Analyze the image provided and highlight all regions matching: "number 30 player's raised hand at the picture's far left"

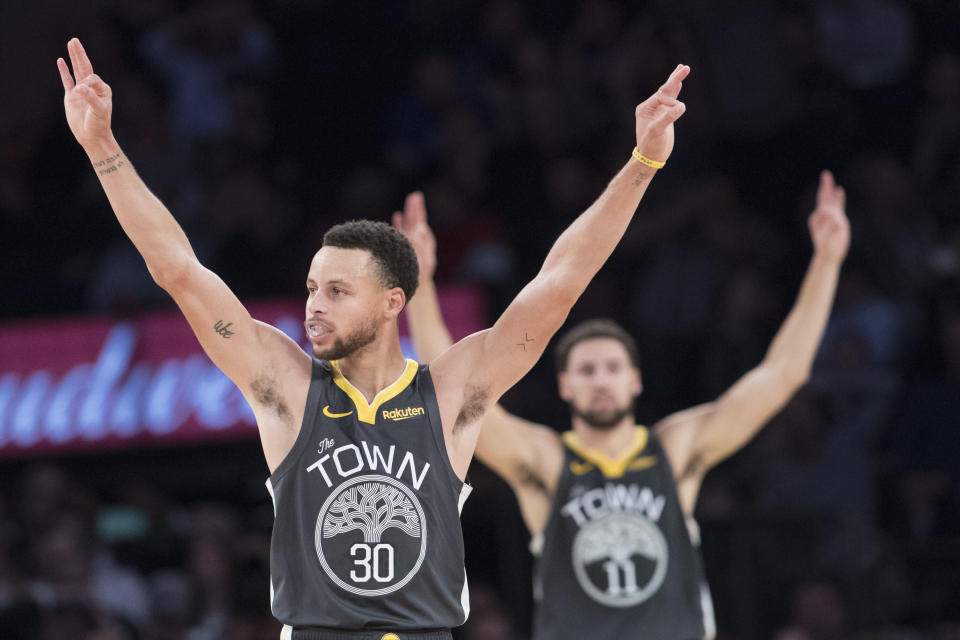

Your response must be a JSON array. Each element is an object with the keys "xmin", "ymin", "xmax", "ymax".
[{"xmin": 57, "ymin": 38, "xmax": 113, "ymax": 148}]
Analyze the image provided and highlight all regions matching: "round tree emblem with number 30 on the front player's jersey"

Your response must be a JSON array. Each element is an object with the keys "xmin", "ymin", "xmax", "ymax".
[{"xmin": 314, "ymin": 475, "xmax": 427, "ymax": 596}]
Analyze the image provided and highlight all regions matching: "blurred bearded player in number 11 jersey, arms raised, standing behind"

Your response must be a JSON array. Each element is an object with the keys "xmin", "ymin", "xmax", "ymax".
[{"xmin": 402, "ymin": 171, "xmax": 850, "ymax": 640}]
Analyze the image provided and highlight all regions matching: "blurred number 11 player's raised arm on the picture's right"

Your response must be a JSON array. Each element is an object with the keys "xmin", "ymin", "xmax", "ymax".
[{"xmin": 657, "ymin": 171, "xmax": 850, "ymax": 512}]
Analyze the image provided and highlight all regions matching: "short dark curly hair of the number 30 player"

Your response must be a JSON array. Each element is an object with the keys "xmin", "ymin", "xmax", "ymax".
[{"xmin": 323, "ymin": 220, "xmax": 420, "ymax": 300}]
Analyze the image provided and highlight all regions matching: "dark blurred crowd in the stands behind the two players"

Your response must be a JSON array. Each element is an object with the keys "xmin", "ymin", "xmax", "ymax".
[{"xmin": 0, "ymin": 0, "xmax": 960, "ymax": 640}]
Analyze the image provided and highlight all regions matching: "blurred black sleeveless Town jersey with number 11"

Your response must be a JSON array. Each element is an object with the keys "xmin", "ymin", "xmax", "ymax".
[{"xmin": 533, "ymin": 427, "xmax": 715, "ymax": 640}]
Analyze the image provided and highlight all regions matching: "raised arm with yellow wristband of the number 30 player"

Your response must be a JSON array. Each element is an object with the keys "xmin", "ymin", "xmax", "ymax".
[{"xmin": 433, "ymin": 65, "xmax": 690, "ymax": 478}]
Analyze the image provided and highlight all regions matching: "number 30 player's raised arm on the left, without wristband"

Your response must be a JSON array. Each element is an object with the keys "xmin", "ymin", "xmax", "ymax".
[{"xmin": 57, "ymin": 38, "xmax": 310, "ymax": 469}]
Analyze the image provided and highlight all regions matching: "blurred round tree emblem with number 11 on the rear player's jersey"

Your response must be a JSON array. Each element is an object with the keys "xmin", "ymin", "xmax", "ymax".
[{"xmin": 573, "ymin": 511, "xmax": 668, "ymax": 607}]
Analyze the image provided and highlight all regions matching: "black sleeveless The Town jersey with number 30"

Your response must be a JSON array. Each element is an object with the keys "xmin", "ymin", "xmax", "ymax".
[{"xmin": 267, "ymin": 360, "xmax": 470, "ymax": 631}]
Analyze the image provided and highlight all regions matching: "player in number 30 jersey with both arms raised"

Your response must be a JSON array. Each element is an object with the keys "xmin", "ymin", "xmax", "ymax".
[{"xmin": 57, "ymin": 39, "xmax": 690, "ymax": 640}]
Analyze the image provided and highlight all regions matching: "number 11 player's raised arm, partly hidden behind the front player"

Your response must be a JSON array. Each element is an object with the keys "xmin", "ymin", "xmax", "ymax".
[{"xmin": 393, "ymin": 192, "xmax": 563, "ymax": 532}]
